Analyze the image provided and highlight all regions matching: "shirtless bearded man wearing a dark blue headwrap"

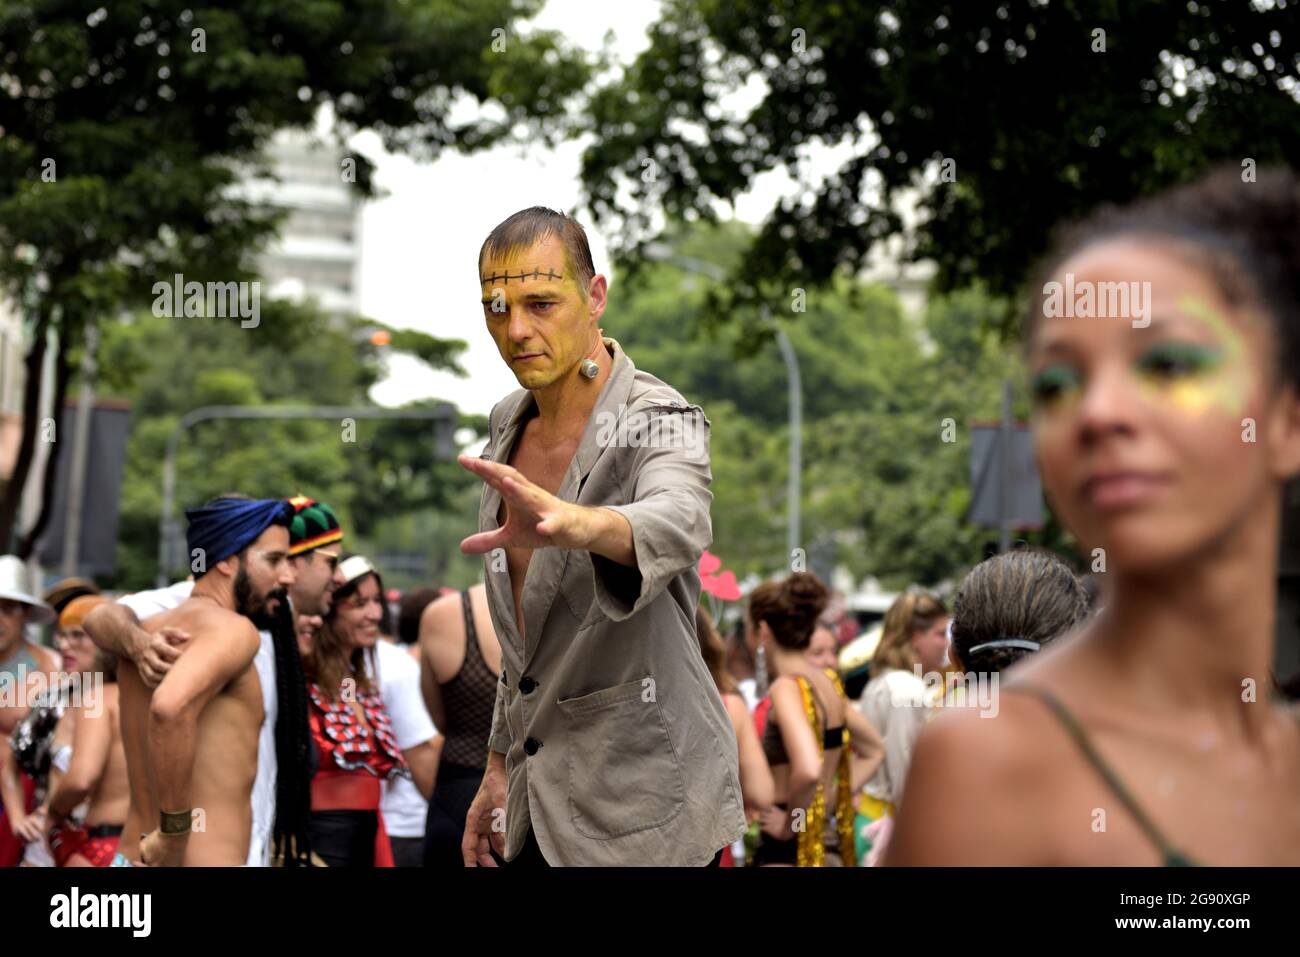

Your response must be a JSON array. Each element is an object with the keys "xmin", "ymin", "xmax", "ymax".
[{"xmin": 118, "ymin": 498, "xmax": 294, "ymax": 866}]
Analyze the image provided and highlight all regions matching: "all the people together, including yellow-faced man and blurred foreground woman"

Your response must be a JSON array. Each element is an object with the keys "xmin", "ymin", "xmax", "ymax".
[{"xmin": 0, "ymin": 170, "xmax": 1300, "ymax": 867}]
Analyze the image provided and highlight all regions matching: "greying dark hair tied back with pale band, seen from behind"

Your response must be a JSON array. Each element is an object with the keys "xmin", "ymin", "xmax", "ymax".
[{"xmin": 953, "ymin": 549, "xmax": 1088, "ymax": 674}]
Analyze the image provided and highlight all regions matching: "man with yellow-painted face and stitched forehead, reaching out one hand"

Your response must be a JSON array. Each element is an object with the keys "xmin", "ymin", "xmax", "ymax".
[{"xmin": 460, "ymin": 207, "xmax": 745, "ymax": 866}]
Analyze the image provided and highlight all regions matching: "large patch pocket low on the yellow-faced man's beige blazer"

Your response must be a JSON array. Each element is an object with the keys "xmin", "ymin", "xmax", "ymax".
[{"xmin": 556, "ymin": 677, "xmax": 685, "ymax": 840}]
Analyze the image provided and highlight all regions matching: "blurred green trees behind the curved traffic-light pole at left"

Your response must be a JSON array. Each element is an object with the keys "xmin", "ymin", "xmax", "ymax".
[{"xmin": 99, "ymin": 302, "xmax": 486, "ymax": 588}]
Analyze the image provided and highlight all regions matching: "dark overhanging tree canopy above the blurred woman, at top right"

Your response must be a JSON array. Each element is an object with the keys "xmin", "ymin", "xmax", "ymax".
[{"xmin": 582, "ymin": 0, "xmax": 1300, "ymax": 325}]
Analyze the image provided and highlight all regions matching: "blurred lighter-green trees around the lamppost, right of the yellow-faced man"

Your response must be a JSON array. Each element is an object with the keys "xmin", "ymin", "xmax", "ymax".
[{"xmin": 613, "ymin": 224, "xmax": 1063, "ymax": 586}]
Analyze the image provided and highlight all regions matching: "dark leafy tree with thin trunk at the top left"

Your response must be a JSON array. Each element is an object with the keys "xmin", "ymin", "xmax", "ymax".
[{"xmin": 0, "ymin": 0, "xmax": 589, "ymax": 551}]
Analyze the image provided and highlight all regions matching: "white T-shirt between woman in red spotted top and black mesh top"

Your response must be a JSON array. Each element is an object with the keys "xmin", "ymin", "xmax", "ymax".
[{"xmin": 374, "ymin": 638, "xmax": 438, "ymax": 837}]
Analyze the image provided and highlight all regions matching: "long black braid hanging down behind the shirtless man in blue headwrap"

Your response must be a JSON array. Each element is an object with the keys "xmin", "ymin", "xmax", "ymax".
[{"xmin": 270, "ymin": 601, "xmax": 312, "ymax": 867}]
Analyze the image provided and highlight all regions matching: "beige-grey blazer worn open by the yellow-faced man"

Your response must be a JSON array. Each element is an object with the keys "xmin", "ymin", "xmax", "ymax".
[{"xmin": 478, "ymin": 339, "xmax": 745, "ymax": 866}]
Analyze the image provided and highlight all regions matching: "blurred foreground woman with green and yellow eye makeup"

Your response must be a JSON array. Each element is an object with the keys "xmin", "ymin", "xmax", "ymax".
[{"xmin": 888, "ymin": 168, "xmax": 1300, "ymax": 866}]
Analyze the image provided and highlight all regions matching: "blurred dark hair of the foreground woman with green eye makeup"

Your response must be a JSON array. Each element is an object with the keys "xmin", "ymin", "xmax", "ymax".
[{"xmin": 1024, "ymin": 165, "xmax": 1300, "ymax": 387}]
